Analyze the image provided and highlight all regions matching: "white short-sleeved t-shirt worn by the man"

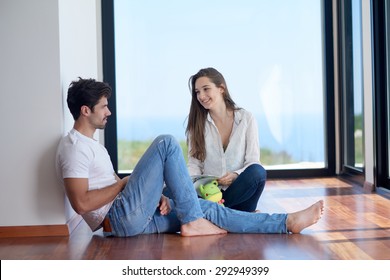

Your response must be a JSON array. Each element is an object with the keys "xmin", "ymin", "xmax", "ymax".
[{"xmin": 56, "ymin": 128, "xmax": 116, "ymax": 231}]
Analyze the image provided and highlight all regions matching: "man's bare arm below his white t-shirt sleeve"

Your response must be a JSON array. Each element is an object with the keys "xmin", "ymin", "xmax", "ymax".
[{"xmin": 64, "ymin": 176, "xmax": 128, "ymax": 215}]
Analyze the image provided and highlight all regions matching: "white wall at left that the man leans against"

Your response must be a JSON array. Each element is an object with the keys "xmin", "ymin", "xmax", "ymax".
[{"xmin": 0, "ymin": 0, "xmax": 101, "ymax": 226}]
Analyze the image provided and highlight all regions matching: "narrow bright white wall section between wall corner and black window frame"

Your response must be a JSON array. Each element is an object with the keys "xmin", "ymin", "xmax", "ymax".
[{"xmin": 58, "ymin": 0, "xmax": 101, "ymax": 220}]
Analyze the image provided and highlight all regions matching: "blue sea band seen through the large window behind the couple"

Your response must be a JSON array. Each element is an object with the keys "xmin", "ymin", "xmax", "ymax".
[{"xmin": 118, "ymin": 112, "xmax": 325, "ymax": 162}]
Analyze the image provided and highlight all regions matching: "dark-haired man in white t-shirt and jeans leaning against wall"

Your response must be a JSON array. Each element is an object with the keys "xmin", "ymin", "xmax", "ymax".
[{"xmin": 56, "ymin": 78, "xmax": 323, "ymax": 236}]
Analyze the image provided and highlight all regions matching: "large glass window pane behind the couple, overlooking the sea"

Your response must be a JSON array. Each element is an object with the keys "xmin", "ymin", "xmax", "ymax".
[{"xmin": 115, "ymin": 0, "xmax": 326, "ymax": 172}]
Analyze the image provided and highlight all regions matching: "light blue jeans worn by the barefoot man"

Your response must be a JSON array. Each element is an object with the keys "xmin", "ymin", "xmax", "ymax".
[{"xmin": 107, "ymin": 135, "xmax": 287, "ymax": 236}]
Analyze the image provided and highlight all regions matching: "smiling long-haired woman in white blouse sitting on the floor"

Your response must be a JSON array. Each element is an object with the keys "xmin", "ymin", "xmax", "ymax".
[{"xmin": 186, "ymin": 68, "xmax": 266, "ymax": 212}]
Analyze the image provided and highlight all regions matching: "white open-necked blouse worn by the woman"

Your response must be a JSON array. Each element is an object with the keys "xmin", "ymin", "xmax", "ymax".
[{"xmin": 187, "ymin": 109, "xmax": 260, "ymax": 180}]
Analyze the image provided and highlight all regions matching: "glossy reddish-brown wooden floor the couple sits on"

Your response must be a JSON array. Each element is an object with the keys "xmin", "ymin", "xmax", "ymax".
[{"xmin": 0, "ymin": 178, "xmax": 390, "ymax": 260}]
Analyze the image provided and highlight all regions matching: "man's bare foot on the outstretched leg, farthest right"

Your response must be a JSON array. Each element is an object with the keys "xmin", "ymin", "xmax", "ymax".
[{"xmin": 286, "ymin": 200, "xmax": 324, "ymax": 233}]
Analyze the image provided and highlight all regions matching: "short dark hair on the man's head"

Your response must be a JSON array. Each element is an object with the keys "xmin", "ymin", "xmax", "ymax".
[{"xmin": 66, "ymin": 77, "xmax": 112, "ymax": 120}]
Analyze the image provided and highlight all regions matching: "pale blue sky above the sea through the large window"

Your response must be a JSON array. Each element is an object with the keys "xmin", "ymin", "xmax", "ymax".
[{"xmin": 115, "ymin": 0, "xmax": 322, "ymax": 117}]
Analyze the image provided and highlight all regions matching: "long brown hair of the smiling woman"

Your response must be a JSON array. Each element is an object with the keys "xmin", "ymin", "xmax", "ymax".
[{"xmin": 186, "ymin": 67, "xmax": 238, "ymax": 161}]
